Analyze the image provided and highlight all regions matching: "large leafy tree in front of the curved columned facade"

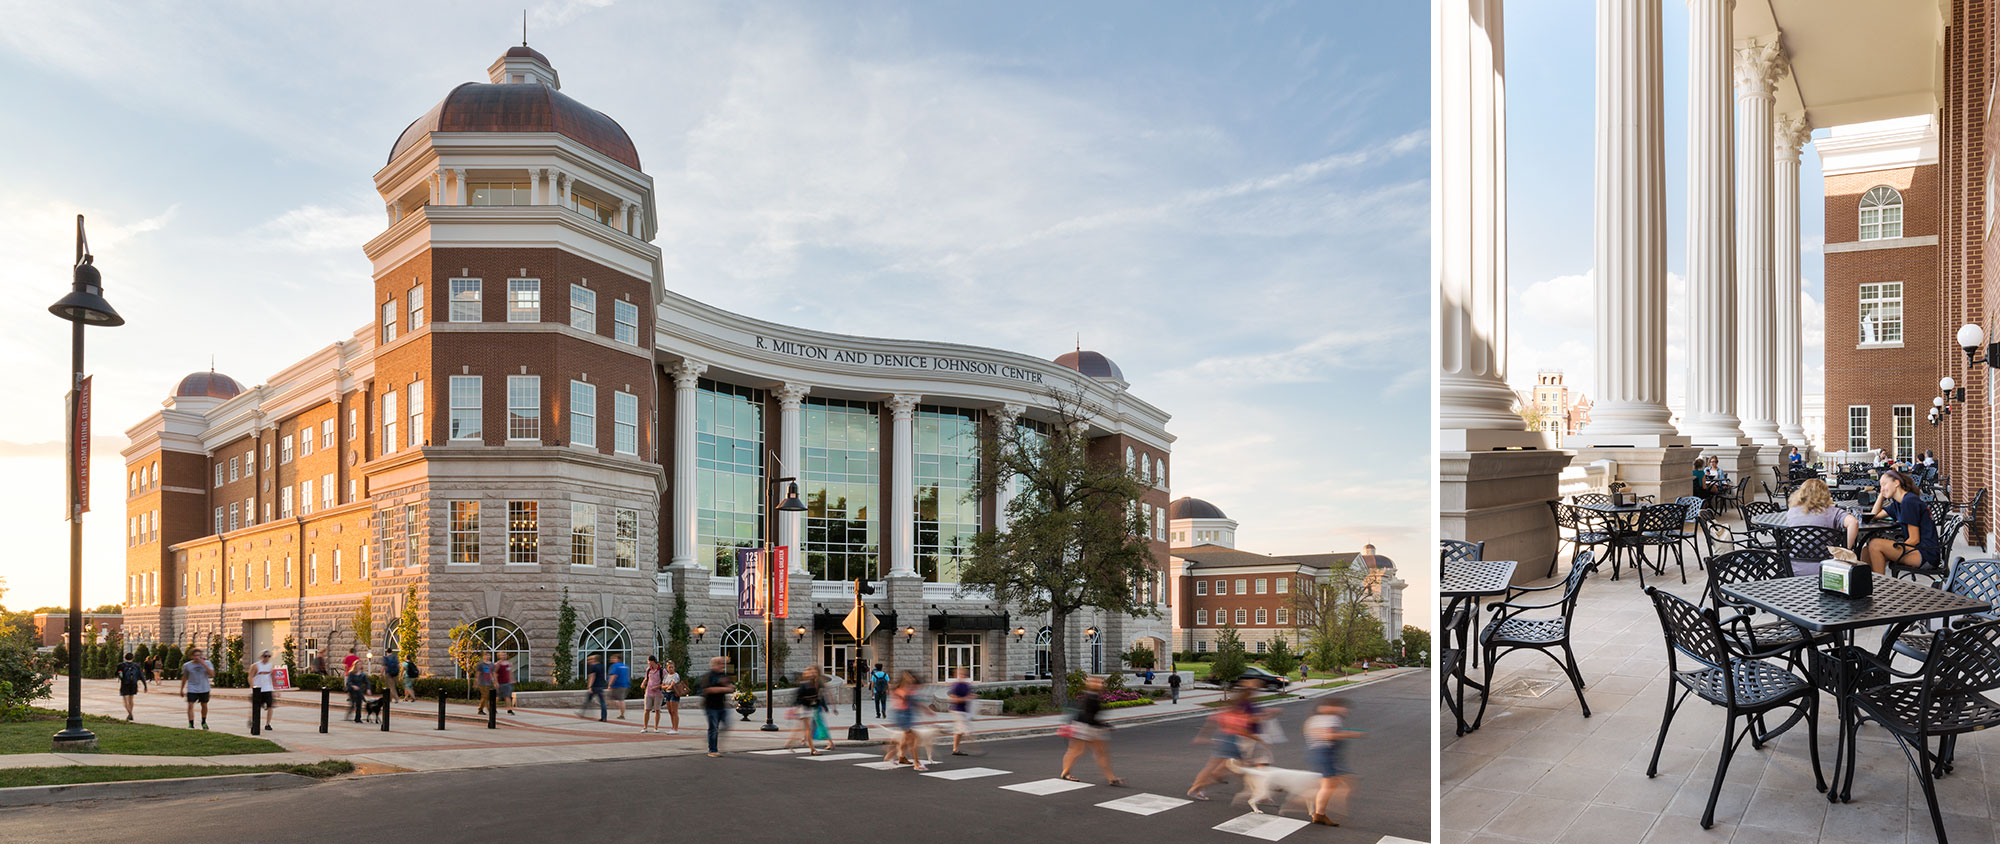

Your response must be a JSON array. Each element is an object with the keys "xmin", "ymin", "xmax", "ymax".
[{"xmin": 958, "ymin": 390, "xmax": 1158, "ymax": 706}]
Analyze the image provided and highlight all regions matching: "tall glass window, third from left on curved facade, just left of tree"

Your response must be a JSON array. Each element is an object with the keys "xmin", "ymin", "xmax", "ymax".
[{"xmin": 912, "ymin": 406, "xmax": 980, "ymax": 584}]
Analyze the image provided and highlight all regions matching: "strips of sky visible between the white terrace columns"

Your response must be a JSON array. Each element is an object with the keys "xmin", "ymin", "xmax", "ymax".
[{"xmin": 1506, "ymin": 0, "xmax": 1826, "ymax": 418}]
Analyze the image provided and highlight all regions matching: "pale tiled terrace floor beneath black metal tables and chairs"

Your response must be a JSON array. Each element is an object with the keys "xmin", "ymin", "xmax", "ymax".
[{"xmin": 1438, "ymin": 524, "xmax": 2000, "ymax": 844}]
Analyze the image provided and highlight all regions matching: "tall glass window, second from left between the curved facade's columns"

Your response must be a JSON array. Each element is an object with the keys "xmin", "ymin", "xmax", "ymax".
[{"xmin": 800, "ymin": 398, "xmax": 882, "ymax": 580}]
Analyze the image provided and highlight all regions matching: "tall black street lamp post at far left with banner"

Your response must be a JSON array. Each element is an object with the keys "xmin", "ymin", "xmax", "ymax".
[{"xmin": 48, "ymin": 214, "xmax": 124, "ymax": 752}]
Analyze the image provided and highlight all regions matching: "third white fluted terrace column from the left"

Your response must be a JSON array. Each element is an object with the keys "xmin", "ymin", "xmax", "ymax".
[{"xmin": 1680, "ymin": 0, "xmax": 1744, "ymax": 446}]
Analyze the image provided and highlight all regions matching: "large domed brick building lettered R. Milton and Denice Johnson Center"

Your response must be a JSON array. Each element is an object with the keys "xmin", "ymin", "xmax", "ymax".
[{"xmin": 124, "ymin": 46, "xmax": 1172, "ymax": 678}]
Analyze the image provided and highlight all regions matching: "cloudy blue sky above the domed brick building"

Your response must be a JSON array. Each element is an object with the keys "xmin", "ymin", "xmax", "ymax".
[{"xmin": 0, "ymin": 0, "xmax": 1432, "ymax": 620}]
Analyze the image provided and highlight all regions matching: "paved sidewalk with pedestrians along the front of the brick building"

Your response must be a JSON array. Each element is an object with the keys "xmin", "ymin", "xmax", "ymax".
[{"xmin": 11, "ymin": 668, "xmax": 1424, "ymax": 770}]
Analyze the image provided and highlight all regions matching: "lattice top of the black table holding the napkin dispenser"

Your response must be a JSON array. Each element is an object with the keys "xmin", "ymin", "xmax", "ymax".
[{"xmin": 1722, "ymin": 576, "xmax": 1992, "ymax": 632}]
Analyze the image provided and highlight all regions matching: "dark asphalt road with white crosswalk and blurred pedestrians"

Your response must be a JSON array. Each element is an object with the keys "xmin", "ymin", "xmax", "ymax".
[{"xmin": 0, "ymin": 674, "xmax": 1434, "ymax": 844}]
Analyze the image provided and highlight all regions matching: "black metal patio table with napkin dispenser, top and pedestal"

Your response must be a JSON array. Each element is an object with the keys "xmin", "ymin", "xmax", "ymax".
[{"xmin": 1722, "ymin": 576, "xmax": 1992, "ymax": 802}]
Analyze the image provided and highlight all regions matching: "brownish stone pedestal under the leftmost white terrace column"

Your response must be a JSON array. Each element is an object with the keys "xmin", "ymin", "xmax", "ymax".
[{"xmin": 1438, "ymin": 450, "xmax": 1572, "ymax": 584}]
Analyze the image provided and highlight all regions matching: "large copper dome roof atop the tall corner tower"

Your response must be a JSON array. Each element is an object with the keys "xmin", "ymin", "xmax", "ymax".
[{"xmin": 388, "ymin": 81, "xmax": 638, "ymax": 170}]
